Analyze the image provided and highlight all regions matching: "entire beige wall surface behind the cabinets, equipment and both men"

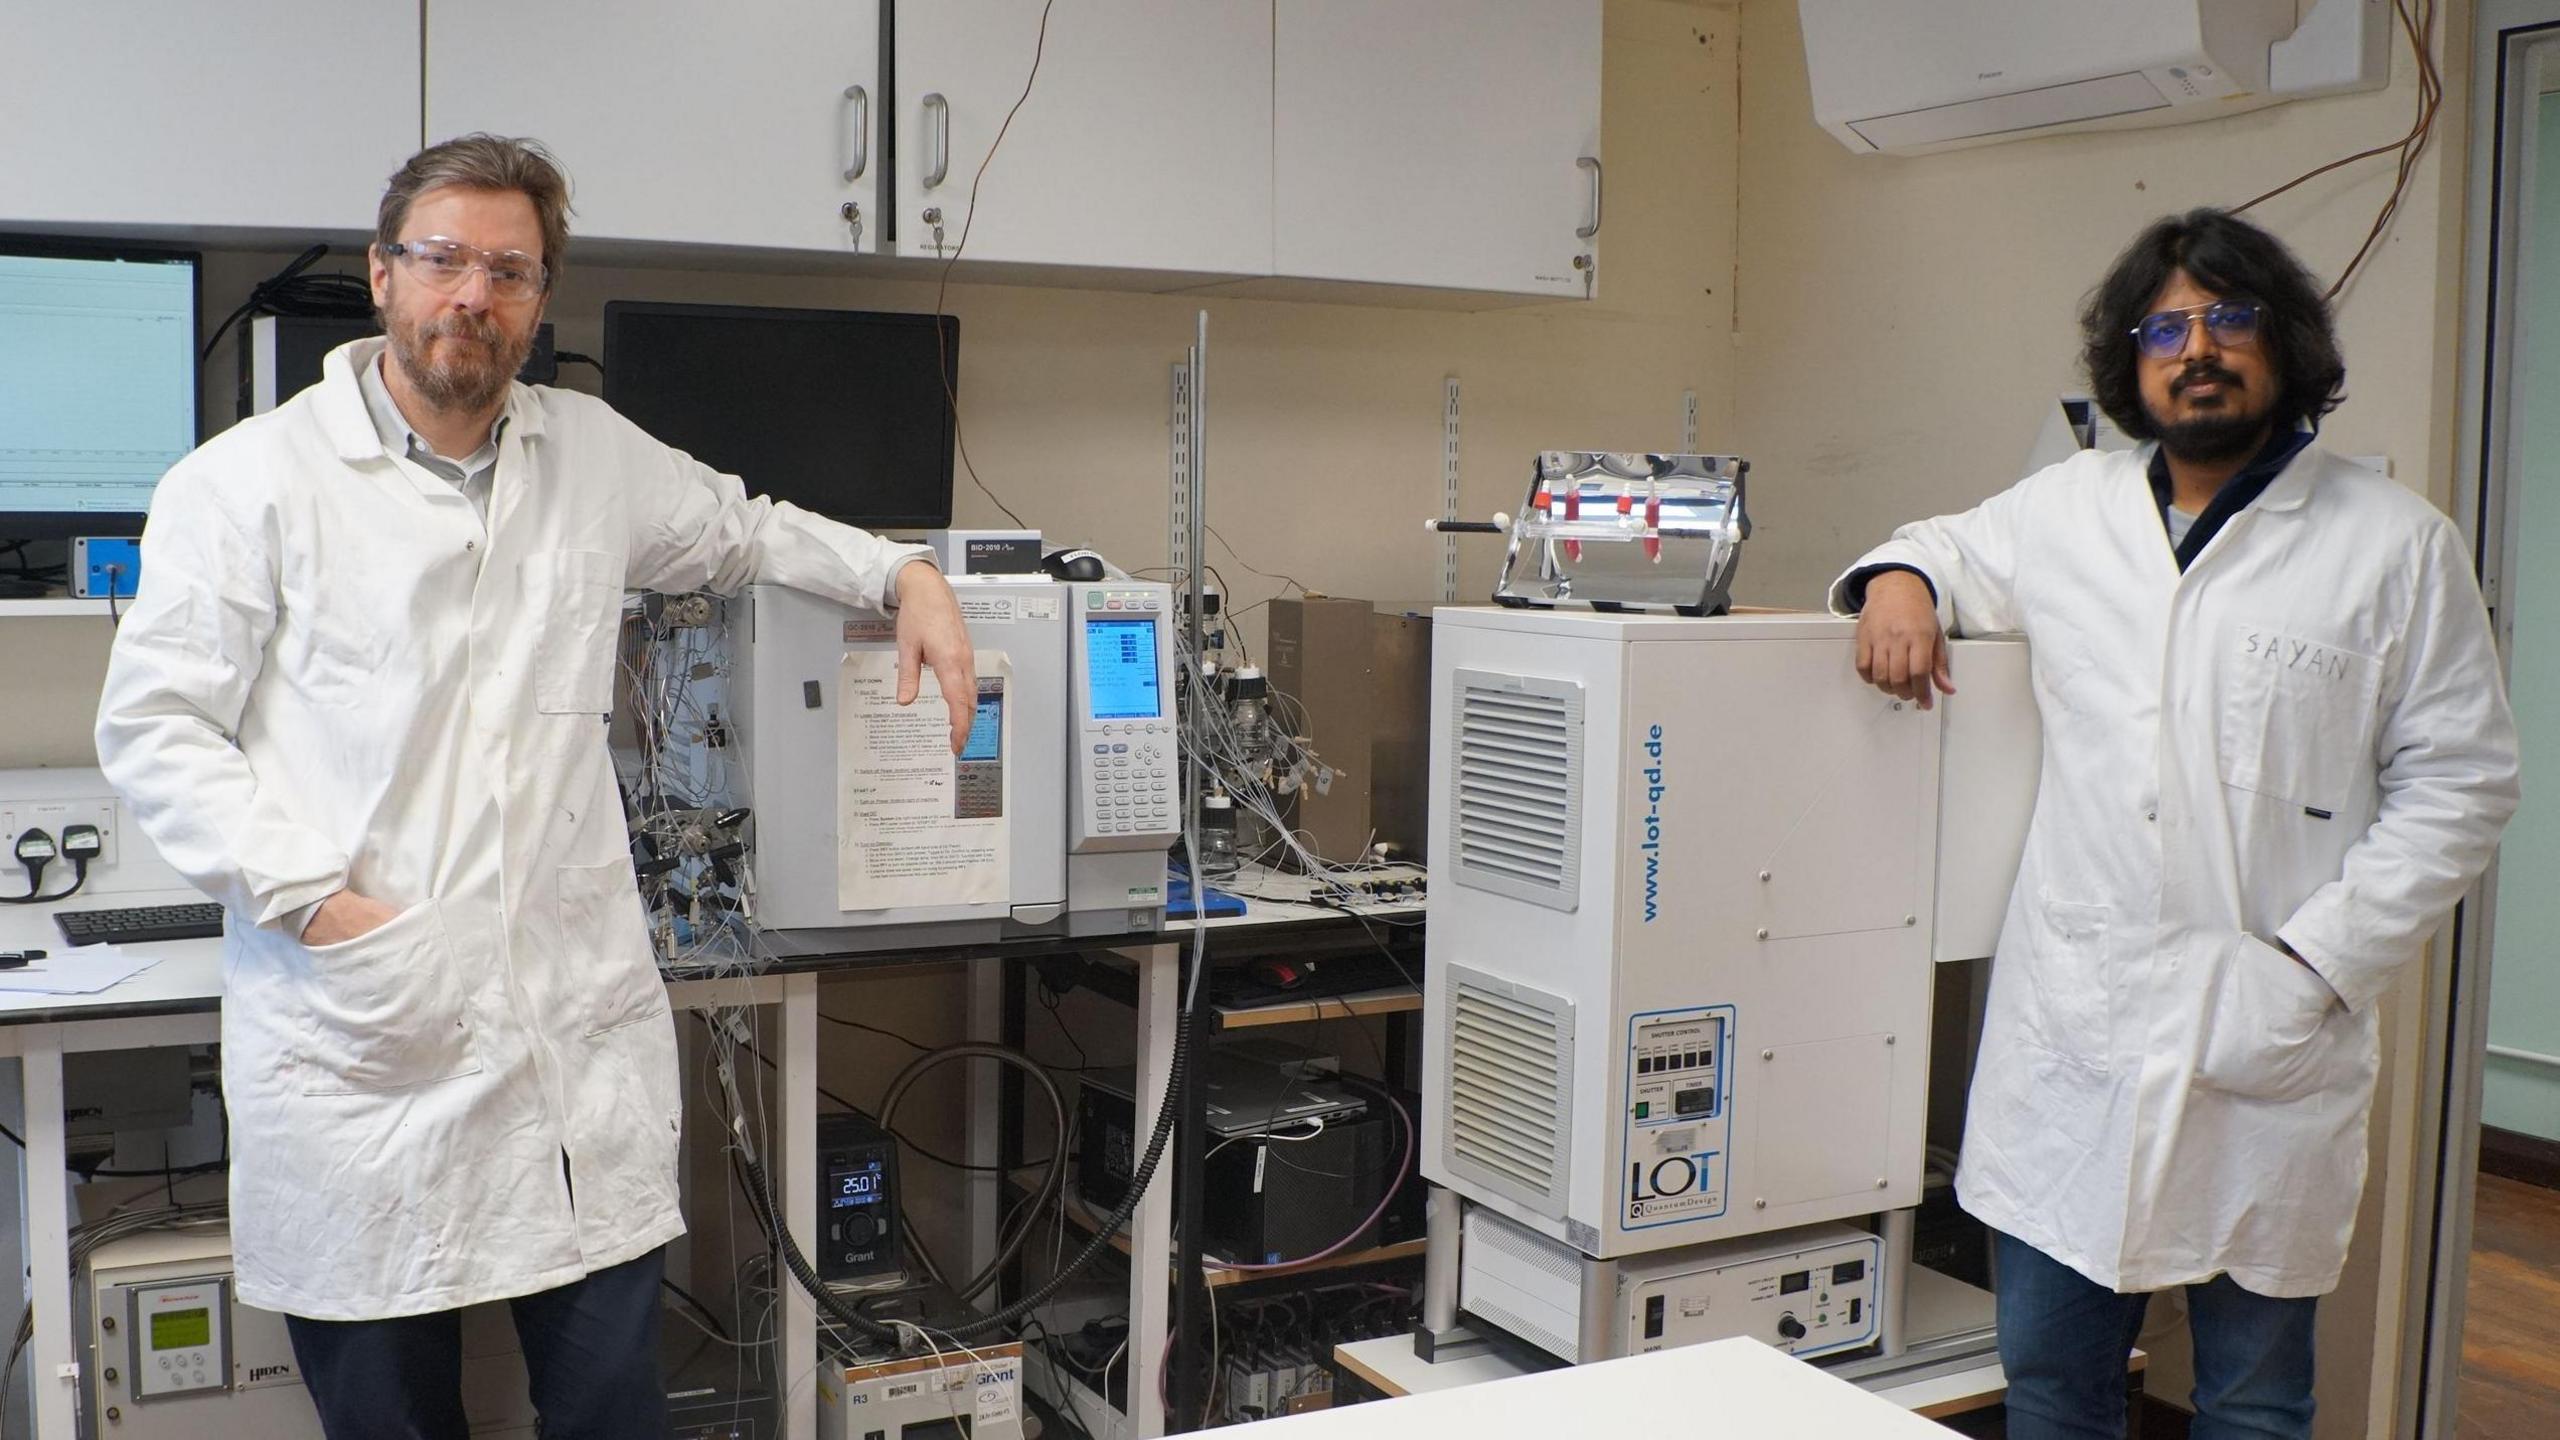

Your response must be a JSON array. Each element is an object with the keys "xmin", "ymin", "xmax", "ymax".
[{"xmin": 0, "ymin": 0, "xmax": 2463, "ymax": 1435}]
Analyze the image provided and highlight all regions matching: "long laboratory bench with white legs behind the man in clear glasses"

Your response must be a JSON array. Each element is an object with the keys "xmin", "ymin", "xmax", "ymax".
[{"xmin": 0, "ymin": 860, "xmax": 1421, "ymax": 1440}]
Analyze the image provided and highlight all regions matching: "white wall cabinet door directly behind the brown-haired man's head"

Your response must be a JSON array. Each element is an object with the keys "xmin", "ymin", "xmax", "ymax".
[{"xmin": 428, "ymin": 0, "xmax": 883, "ymax": 254}]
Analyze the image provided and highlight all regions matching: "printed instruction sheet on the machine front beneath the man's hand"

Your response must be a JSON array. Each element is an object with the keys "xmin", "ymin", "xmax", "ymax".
[{"xmin": 835, "ymin": 651, "xmax": 1014, "ymax": 910}]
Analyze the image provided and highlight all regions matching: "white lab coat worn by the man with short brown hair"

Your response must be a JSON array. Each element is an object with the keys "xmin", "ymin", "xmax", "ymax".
[{"xmin": 97, "ymin": 341, "xmax": 919, "ymax": 1320}]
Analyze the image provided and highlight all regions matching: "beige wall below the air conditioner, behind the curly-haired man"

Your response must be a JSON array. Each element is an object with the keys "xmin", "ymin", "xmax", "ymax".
[{"xmin": 1725, "ymin": 0, "xmax": 2465, "ymax": 1437}]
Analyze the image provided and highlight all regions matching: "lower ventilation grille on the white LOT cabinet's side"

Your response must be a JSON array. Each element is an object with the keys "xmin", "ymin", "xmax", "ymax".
[{"xmin": 1446, "ymin": 966, "xmax": 1572, "ymax": 1215}]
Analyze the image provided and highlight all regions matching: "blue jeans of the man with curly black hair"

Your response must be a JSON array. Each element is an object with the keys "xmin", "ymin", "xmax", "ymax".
[{"xmin": 1999, "ymin": 1219, "xmax": 2317, "ymax": 1440}]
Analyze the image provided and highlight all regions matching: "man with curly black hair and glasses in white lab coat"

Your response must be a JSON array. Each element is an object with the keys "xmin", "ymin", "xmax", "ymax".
[{"xmin": 1830, "ymin": 210, "xmax": 2516, "ymax": 1440}]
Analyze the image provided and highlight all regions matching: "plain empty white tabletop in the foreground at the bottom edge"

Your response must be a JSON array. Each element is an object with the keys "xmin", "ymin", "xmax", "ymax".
[{"xmin": 1254, "ymin": 1340, "xmax": 1946, "ymax": 1440}]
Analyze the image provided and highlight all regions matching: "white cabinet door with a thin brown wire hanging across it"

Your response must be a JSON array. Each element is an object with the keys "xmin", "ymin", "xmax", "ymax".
[{"xmin": 893, "ymin": 0, "xmax": 1272, "ymax": 277}]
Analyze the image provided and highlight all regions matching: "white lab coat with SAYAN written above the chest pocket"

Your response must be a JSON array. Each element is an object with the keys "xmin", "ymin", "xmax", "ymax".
[{"xmin": 1833, "ymin": 446, "xmax": 2516, "ymax": 1297}]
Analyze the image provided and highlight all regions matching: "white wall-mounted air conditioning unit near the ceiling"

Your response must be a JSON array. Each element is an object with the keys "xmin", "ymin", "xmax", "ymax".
[{"xmin": 1797, "ymin": 0, "xmax": 2391, "ymax": 154}]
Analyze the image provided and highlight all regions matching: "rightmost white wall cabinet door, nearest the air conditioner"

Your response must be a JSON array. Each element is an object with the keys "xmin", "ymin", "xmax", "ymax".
[{"xmin": 1272, "ymin": 0, "xmax": 1605, "ymax": 297}]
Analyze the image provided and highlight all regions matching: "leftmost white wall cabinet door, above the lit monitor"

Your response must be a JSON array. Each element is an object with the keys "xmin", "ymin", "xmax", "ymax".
[{"xmin": 0, "ymin": 0, "xmax": 417, "ymax": 233}]
